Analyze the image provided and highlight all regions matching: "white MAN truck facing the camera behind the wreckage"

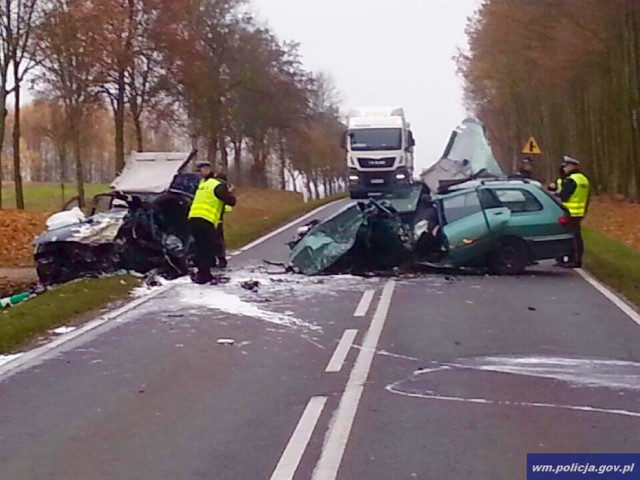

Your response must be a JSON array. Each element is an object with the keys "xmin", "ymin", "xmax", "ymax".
[{"xmin": 342, "ymin": 107, "xmax": 415, "ymax": 198}]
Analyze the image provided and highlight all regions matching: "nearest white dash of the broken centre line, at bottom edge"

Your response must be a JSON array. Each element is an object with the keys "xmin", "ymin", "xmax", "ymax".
[{"xmin": 271, "ymin": 397, "xmax": 327, "ymax": 480}]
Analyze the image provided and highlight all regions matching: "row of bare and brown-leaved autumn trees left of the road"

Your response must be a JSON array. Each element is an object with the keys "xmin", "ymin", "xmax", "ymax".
[{"xmin": 0, "ymin": 0, "xmax": 344, "ymax": 208}]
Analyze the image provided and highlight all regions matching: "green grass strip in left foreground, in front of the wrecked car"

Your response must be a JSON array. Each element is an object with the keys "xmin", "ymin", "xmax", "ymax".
[{"xmin": 0, "ymin": 276, "xmax": 140, "ymax": 353}]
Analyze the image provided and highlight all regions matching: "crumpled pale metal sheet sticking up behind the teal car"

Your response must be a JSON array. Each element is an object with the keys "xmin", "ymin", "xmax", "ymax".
[{"xmin": 420, "ymin": 118, "xmax": 504, "ymax": 192}]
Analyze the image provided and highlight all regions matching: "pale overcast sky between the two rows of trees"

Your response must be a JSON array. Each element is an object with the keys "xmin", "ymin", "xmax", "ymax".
[{"xmin": 252, "ymin": 0, "xmax": 480, "ymax": 172}]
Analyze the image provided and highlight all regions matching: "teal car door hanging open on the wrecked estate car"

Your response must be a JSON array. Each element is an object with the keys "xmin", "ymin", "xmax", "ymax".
[{"xmin": 440, "ymin": 190, "xmax": 500, "ymax": 266}]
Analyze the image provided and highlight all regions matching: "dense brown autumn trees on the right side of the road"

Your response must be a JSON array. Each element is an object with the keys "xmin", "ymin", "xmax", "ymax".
[{"xmin": 458, "ymin": 0, "xmax": 640, "ymax": 200}]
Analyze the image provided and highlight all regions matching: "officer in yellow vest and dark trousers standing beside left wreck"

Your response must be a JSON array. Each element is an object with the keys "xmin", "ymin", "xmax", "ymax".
[{"xmin": 189, "ymin": 161, "xmax": 236, "ymax": 284}]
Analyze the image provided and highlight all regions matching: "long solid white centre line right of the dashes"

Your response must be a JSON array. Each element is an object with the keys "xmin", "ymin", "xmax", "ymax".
[{"xmin": 312, "ymin": 280, "xmax": 395, "ymax": 480}]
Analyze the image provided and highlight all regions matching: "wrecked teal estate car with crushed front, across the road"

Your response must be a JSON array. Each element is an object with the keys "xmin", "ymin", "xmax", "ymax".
[{"xmin": 290, "ymin": 179, "xmax": 573, "ymax": 275}]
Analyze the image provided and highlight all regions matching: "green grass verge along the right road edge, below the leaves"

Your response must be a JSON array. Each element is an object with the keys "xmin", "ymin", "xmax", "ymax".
[{"xmin": 583, "ymin": 228, "xmax": 640, "ymax": 307}]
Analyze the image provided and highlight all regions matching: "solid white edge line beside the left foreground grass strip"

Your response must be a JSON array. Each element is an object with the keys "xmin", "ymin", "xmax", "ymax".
[{"xmin": 0, "ymin": 284, "xmax": 175, "ymax": 382}]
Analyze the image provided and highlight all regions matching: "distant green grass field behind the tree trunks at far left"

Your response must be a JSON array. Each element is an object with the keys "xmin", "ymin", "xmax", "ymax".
[{"xmin": 2, "ymin": 182, "xmax": 109, "ymax": 212}]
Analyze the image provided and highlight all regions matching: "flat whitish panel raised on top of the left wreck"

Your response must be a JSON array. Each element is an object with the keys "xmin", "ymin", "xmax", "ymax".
[{"xmin": 111, "ymin": 152, "xmax": 195, "ymax": 193}]
